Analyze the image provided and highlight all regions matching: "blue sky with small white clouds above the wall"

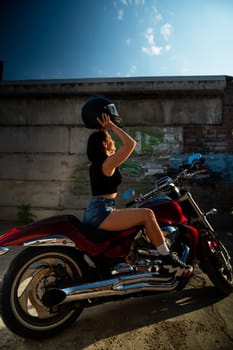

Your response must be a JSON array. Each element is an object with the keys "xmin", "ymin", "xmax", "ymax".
[{"xmin": 0, "ymin": 0, "xmax": 233, "ymax": 80}]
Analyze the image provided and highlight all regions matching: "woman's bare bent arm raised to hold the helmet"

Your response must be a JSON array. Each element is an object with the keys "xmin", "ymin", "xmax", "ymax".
[{"xmin": 98, "ymin": 113, "xmax": 137, "ymax": 176}]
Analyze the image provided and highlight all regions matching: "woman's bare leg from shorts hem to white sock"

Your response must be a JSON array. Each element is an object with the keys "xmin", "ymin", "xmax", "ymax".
[{"xmin": 99, "ymin": 208, "xmax": 165, "ymax": 247}]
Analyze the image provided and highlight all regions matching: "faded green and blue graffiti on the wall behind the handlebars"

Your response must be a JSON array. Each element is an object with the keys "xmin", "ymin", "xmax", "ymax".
[{"xmin": 121, "ymin": 127, "xmax": 233, "ymax": 183}]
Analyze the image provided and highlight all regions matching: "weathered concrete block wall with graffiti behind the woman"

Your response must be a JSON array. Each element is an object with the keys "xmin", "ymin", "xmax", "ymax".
[{"xmin": 0, "ymin": 76, "xmax": 233, "ymax": 226}]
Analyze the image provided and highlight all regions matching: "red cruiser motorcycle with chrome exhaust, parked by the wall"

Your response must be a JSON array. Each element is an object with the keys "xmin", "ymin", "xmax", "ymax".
[{"xmin": 0, "ymin": 154, "xmax": 233, "ymax": 339}]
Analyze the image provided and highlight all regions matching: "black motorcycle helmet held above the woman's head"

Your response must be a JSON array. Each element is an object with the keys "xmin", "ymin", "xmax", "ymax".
[{"xmin": 82, "ymin": 96, "xmax": 122, "ymax": 129}]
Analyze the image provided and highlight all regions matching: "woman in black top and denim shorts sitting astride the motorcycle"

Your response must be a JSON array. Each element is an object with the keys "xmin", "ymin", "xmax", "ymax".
[{"xmin": 83, "ymin": 113, "xmax": 193, "ymax": 277}]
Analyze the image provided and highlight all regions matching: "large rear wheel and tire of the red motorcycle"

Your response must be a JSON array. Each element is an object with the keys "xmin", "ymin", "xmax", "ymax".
[{"xmin": 0, "ymin": 247, "xmax": 84, "ymax": 339}]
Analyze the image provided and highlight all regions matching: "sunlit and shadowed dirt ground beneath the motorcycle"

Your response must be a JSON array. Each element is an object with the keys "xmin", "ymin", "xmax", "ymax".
[{"xmin": 0, "ymin": 232, "xmax": 233, "ymax": 350}]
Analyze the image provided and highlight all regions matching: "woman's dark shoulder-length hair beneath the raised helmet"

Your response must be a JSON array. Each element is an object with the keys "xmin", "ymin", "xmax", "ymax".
[{"xmin": 87, "ymin": 130, "xmax": 107, "ymax": 162}]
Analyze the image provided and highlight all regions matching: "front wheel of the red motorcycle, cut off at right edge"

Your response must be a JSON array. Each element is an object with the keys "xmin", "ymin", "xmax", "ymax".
[{"xmin": 202, "ymin": 242, "xmax": 233, "ymax": 295}]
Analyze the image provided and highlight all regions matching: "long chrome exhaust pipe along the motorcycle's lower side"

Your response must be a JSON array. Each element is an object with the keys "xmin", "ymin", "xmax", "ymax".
[{"xmin": 42, "ymin": 272, "xmax": 179, "ymax": 307}]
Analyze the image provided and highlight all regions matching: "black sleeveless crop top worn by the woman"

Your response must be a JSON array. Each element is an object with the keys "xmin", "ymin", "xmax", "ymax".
[{"xmin": 89, "ymin": 162, "xmax": 121, "ymax": 196}]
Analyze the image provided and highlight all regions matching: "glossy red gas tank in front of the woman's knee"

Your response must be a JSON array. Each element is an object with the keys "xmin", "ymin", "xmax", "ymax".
[{"xmin": 140, "ymin": 198, "xmax": 188, "ymax": 225}]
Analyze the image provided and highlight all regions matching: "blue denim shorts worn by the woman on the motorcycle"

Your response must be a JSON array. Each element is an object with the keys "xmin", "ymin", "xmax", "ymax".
[{"xmin": 83, "ymin": 196, "xmax": 115, "ymax": 228}]
